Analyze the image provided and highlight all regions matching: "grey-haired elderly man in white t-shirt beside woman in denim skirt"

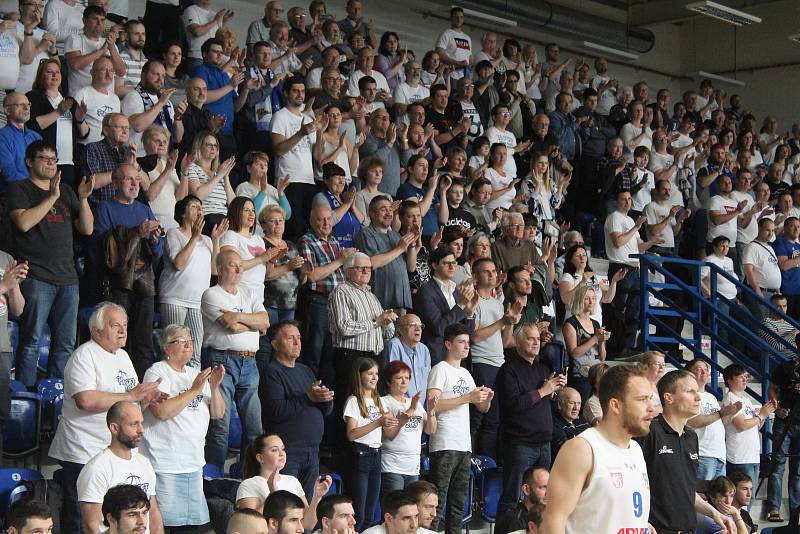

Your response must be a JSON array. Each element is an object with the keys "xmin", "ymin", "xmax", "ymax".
[{"xmin": 50, "ymin": 302, "xmax": 164, "ymax": 532}]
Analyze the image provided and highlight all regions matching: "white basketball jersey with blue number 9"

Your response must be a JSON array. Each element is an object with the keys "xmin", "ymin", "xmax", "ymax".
[{"xmin": 566, "ymin": 428, "xmax": 650, "ymax": 534}]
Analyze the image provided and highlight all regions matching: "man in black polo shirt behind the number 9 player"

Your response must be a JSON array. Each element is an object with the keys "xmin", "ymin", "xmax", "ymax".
[{"xmin": 636, "ymin": 368, "xmax": 736, "ymax": 533}]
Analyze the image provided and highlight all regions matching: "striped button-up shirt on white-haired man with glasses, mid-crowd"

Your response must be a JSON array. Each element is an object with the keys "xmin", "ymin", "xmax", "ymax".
[{"xmin": 328, "ymin": 280, "xmax": 394, "ymax": 354}]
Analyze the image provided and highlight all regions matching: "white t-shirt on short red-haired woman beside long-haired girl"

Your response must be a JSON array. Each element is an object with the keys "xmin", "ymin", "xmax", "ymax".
[{"xmin": 381, "ymin": 395, "xmax": 425, "ymax": 475}]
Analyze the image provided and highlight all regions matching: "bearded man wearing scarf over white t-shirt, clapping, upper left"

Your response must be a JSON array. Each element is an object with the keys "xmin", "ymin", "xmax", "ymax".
[{"xmin": 122, "ymin": 59, "xmax": 188, "ymax": 157}]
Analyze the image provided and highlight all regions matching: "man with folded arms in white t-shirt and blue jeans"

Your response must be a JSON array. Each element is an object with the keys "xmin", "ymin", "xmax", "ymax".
[{"xmin": 201, "ymin": 249, "xmax": 269, "ymax": 467}]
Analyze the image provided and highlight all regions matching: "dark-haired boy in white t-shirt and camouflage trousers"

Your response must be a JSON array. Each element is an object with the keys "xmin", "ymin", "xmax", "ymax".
[{"xmin": 427, "ymin": 322, "xmax": 494, "ymax": 534}]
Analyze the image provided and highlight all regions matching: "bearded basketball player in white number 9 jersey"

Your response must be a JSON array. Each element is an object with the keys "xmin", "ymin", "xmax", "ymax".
[{"xmin": 542, "ymin": 365, "xmax": 652, "ymax": 534}]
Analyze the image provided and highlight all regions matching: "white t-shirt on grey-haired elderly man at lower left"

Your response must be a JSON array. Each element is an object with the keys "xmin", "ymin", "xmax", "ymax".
[{"xmin": 50, "ymin": 341, "xmax": 139, "ymax": 464}]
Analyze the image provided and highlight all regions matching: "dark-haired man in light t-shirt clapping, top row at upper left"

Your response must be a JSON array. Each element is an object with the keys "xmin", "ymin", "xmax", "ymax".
[{"xmin": 64, "ymin": 6, "xmax": 125, "ymax": 96}]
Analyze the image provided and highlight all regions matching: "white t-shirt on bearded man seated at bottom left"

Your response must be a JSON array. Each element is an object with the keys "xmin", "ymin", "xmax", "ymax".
[{"xmin": 78, "ymin": 448, "xmax": 156, "ymax": 532}]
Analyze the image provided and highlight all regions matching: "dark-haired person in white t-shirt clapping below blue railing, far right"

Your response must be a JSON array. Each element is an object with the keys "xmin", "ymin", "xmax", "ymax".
[{"xmin": 720, "ymin": 363, "xmax": 780, "ymax": 498}]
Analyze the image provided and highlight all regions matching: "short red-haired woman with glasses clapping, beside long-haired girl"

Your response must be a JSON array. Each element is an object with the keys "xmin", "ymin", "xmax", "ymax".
[{"xmin": 381, "ymin": 360, "xmax": 436, "ymax": 495}]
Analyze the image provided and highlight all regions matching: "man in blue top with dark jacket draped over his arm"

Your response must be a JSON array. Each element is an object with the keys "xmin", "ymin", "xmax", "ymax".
[{"xmin": 92, "ymin": 163, "xmax": 164, "ymax": 376}]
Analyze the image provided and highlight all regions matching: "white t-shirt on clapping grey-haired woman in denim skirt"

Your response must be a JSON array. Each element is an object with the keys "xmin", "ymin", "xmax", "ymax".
[{"xmin": 139, "ymin": 361, "xmax": 211, "ymax": 474}]
